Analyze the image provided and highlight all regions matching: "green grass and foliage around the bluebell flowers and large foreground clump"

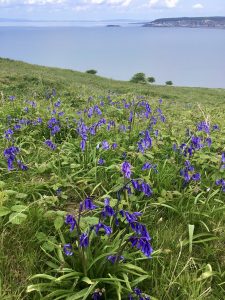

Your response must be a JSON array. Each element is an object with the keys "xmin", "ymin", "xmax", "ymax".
[{"xmin": 0, "ymin": 59, "xmax": 225, "ymax": 300}]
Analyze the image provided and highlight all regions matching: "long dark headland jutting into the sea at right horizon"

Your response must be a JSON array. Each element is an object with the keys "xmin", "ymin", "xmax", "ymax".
[{"xmin": 143, "ymin": 17, "xmax": 225, "ymax": 29}]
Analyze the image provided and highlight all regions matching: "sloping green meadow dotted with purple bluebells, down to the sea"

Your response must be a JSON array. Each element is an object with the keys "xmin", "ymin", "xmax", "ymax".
[{"xmin": 0, "ymin": 59, "xmax": 225, "ymax": 300}]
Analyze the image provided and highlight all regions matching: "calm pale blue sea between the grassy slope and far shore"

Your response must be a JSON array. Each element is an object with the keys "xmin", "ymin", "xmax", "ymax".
[{"xmin": 0, "ymin": 26, "xmax": 225, "ymax": 88}]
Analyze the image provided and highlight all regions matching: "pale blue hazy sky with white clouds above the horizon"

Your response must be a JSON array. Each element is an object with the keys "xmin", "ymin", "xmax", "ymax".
[{"xmin": 0, "ymin": 0, "xmax": 225, "ymax": 20}]
